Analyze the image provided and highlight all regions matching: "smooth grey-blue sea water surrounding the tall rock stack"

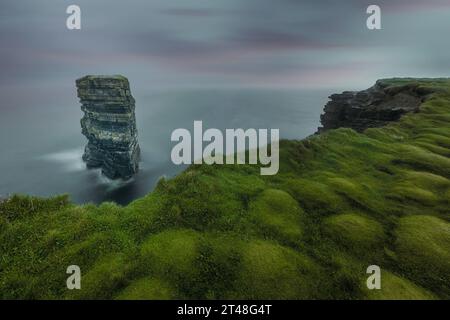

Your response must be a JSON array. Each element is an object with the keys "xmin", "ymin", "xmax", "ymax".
[{"xmin": 0, "ymin": 89, "xmax": 330, "ymax": 204}]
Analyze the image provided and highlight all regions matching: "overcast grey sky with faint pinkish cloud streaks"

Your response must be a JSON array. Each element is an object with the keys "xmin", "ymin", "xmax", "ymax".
[{"xmin": 0, "ymin": 0, "xmax": 450, "ymax": 99}]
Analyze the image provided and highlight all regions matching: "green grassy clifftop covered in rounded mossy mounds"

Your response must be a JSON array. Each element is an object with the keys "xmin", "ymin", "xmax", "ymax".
[{"xmin": 0, "ymin": 79, "xmax": 450, "ymax": 299}]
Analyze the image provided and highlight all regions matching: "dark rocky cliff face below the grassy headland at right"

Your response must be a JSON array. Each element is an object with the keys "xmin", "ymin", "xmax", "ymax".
[{"xmin": 318, "ymin": 80, "xmax": 432, "ymax": 133}]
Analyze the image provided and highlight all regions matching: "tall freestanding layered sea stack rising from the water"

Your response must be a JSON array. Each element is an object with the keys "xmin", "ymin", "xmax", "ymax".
[{"xmin": 76, "ymin": 76, "xmax": 140, "ymax": 179}]
